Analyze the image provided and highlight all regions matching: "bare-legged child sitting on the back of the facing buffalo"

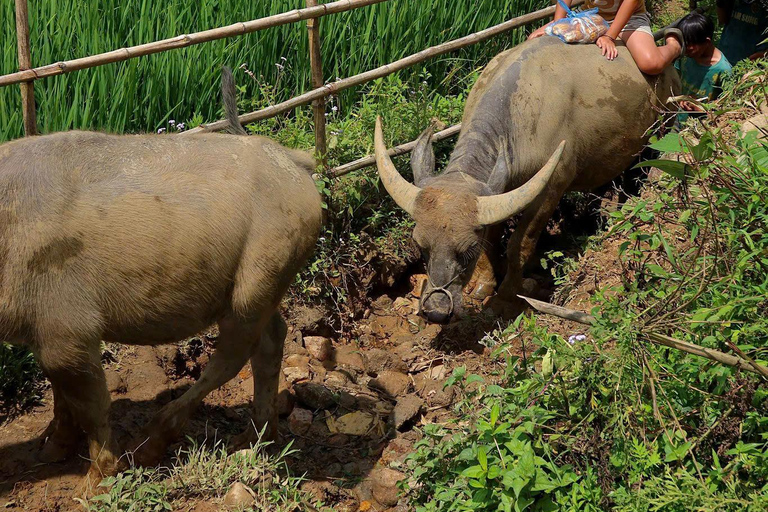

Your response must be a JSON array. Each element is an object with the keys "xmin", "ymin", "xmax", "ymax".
[{"xmin": 529, "ymin": 0, "xmax": 685, "ymax": 75}]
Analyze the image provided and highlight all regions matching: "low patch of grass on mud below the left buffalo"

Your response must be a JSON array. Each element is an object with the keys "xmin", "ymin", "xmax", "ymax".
[{"xmin": 79, "ymin": 436, "xmax": 321, "ymax": 512}]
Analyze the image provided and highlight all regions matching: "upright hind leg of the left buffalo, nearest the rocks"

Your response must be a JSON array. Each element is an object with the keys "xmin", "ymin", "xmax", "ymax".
[{"xmin": 233, "ymin": 312, "xmax": 288, "ymax": 446}]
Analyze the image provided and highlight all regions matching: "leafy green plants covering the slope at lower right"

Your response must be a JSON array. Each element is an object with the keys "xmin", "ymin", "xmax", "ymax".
[{"xmin": 408, "ymin": 69, "xmax": 768, "ymax": 512}]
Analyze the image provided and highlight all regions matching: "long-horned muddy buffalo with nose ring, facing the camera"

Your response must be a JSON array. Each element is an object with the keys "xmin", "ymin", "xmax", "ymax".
[{"xmin": 376, "ymin": 37, "xmax": 680, "ymax": 322}]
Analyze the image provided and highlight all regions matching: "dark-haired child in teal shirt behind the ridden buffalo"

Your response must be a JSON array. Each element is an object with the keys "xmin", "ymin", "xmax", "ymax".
[{"xmin": 675, "ymin": 12, "xmax": 731, "ymax": 122}]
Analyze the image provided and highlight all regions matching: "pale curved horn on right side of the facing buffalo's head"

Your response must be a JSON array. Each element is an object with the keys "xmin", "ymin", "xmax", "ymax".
[{"xmin": 477, "ymin": 141, "xmax": 565, "ymax": 226}]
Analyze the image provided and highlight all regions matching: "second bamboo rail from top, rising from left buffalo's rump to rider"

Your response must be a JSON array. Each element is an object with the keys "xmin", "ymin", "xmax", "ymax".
[{"xmin": 183, "ymin": 0, "xmax": 583, "ymax": 134}]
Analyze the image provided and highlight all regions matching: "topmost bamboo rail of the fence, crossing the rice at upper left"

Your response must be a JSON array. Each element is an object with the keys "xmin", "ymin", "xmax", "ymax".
[{"xmin": 0, "ymin": 0, "xmax": 388, "ymax": 87}]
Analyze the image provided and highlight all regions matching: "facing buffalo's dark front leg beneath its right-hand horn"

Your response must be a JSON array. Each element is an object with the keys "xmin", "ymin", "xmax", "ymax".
[{"xmin": 491, "ymin": 181, "xmax": 568, "ymax": 318}]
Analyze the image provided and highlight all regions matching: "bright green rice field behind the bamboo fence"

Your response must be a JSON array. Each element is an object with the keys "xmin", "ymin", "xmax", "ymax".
[{"xmin": 0, "ymin": 0, "xmax": 549, "ymax": 141}]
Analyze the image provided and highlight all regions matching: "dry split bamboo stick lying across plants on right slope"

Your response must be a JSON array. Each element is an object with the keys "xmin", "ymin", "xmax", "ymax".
[{"xmin": 518, "ymin": 295, "xmax": 768, "ymax": 377}]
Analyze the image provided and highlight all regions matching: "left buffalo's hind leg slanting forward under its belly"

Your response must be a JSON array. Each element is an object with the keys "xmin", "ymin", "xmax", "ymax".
[{"xmin": 130, "ymin": 313, "xmax": 268, "ymax": 466}]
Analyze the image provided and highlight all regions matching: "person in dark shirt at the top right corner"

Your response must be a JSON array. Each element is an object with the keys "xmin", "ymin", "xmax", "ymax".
[{"xmin": 717, "ymin": 0, "xmax": 768, "ymax": 64}]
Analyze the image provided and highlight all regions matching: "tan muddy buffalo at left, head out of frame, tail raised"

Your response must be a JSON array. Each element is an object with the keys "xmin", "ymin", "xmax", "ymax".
[{"xmin": 0, "ymin": 69, "xmax": 322, "ymax": 484}]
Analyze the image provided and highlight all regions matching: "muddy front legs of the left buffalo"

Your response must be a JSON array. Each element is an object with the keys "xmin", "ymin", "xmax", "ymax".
[{"xmin": 37, "ymin": 338, "xmax": 118, "ymax": 494}]
